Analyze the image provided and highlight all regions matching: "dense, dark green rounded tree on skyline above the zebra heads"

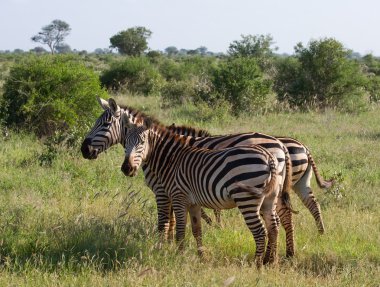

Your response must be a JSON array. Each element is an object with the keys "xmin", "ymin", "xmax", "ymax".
[{"xmin": 110, "ymin": 27, "xmax": 152, "ymax": 56}]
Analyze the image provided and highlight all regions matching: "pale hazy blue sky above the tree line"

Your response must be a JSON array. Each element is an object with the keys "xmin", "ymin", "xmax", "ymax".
[{"xmin": 0, "ymin": 0, "xmax": 380, "ymax": 56}]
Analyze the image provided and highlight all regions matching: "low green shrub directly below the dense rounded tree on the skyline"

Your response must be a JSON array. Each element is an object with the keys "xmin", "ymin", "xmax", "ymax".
[{"xmin": 100, "ymin": 57, "xmax": 164, "ymax": 95}]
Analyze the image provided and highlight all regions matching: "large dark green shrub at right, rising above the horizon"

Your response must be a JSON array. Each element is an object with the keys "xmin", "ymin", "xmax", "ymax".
[{"xmin": 275, "ymin": 38, "xmax": 367, "ymax": 110}]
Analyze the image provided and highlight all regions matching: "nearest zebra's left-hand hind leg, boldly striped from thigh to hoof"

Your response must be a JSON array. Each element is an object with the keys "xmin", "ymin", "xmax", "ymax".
[{"xmin": 230, "ymin": 187, "xmax": 266, "ymax": 268}]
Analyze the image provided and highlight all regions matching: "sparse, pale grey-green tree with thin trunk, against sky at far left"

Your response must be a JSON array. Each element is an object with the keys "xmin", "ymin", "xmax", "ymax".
[{"xmin": 31, "ymin": 20, "xmax": 71, "ymax": 54}]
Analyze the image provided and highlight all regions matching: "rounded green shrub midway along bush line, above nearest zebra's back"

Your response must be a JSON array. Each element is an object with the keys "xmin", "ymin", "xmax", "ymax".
[{"xmin": 212, "ymin": 57, "xmax": 272, "ymax": 114}]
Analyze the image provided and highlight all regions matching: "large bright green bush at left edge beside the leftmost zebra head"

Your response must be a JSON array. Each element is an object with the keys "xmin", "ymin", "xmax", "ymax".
[{"xmin": 0, "ymin": 55, "xmax": 107, "ymax": 136}]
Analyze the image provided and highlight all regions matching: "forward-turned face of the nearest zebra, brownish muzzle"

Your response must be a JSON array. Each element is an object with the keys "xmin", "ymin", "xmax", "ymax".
[{"xmin": 121, "ymin": 114, "xmax": 151, "ymax": 176}]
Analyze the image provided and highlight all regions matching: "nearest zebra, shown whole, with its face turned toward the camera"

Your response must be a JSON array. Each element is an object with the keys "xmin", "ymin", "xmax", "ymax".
[{"xmin": 121, "ymin": 114, "xmax": 284, "ymax": 268}]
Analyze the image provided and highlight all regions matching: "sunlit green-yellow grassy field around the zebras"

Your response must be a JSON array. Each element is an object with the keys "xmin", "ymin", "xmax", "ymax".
[{"xmin": 0, "ymin": 97, "xmax": 380, "ymax": 286}]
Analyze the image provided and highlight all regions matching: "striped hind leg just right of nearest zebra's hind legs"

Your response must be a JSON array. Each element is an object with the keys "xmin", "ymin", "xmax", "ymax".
[{"xmin": 276, "ymin": 197, "xmax": 295, "ymax": 257}]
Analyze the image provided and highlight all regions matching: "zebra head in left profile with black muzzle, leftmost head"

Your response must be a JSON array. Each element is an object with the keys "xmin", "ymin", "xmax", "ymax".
[{"xmin": 81, "ymin": 97, "xmax": 121, "ymax": 159}]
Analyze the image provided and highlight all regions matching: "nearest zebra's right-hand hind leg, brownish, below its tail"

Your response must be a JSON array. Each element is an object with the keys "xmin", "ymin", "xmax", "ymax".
[{"xmin": 261, "ymin": 193, "xmax": 279, "ymax": 264}]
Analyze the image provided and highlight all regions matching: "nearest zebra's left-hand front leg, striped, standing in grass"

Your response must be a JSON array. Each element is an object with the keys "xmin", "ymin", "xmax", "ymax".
[{"xmin": 173, "ymin": 195, "xmax": 188, "ymax": 251}]
